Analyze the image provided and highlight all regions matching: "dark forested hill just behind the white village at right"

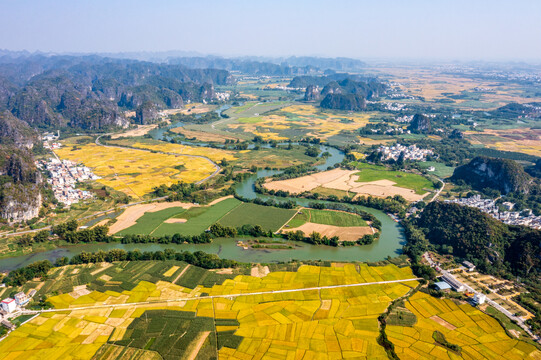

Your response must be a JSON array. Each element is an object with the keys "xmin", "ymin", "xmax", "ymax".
[{"xmin": 452, "ymin": 156, "xmax": 533, "ymax": 194}]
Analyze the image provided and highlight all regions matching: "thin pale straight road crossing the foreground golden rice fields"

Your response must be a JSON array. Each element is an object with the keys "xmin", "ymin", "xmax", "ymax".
[{"xmin": 36, "ymin": 278, "xmax": 421, "ymax": 313}]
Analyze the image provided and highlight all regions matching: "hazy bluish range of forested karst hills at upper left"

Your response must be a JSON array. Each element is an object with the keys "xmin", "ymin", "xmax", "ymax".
[{"xmin": 0, "ymin": 56, "xmax": 231, "ymax": 130}]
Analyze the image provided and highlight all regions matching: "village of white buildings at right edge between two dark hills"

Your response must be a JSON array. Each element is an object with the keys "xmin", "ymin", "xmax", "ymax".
[{"xmin": 445, "ymin": 195, "xmax": 541, "ymax": 229}]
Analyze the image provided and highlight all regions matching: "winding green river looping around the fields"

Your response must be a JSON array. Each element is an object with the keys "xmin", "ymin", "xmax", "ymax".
[{"xmin": 0, "ymin": 124, "xmax": 405, "ymax": 271}]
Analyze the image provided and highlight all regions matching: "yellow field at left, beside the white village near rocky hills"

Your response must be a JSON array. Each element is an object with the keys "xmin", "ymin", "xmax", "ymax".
[{"xmin": 56, "ymin": 144, "xmax": 215, "ymax": 197}]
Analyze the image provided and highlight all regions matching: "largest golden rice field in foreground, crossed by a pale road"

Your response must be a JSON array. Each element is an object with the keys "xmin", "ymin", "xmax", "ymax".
[{"xmin": 0, "ymin": 264, "xmax": 417, "ymax": 360}]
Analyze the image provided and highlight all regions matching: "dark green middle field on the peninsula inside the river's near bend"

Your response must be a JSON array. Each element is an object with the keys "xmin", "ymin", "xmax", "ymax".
[{"xmin": 220, "ymin": 203, "xmax": 296, "ymax": 231}]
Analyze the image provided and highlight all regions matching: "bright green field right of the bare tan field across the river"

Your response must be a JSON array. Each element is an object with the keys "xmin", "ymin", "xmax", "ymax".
[{"xmin": 355, "ymin": 163, "xmax": 435, "ymax": 195}]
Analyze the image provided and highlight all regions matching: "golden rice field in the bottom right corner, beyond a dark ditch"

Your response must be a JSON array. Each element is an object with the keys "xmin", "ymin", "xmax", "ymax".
[{"xmin": 385, "ymin": 292, "xmax": 541, "ymax": 360}]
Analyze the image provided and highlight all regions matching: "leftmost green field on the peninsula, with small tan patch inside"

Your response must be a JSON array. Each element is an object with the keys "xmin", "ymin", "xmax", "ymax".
[{"xmin": 119, "ymin": 199, "xmax": 241, "ymax": 236}]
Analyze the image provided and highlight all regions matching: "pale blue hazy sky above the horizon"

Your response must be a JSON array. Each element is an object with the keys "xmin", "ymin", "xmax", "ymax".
[{"xmin": 0, "ymin": 0, "xmax": 541, "ymax": 60}]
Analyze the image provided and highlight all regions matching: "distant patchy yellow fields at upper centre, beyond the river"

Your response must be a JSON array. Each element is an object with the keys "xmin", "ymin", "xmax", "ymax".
[{"xmin": 228, "ymin": 105, "xmax": 374, "ymax": 140}]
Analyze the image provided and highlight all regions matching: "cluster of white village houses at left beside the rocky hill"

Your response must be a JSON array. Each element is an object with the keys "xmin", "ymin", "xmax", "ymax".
[{"xmin": 37, "ymin": 158, "xmax": 99, "ymax": 206}]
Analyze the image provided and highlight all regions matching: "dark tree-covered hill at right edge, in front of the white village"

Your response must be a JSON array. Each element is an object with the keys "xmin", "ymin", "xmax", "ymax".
[{"xmin": 415, "ymin": 202, "xmax": 541, "ymax": 276}]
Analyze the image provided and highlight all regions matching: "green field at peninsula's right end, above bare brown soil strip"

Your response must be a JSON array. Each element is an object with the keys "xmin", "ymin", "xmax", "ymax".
[{"xmin": 287, "ymin": 209, "xmax": 368, "ymax": 228}]
